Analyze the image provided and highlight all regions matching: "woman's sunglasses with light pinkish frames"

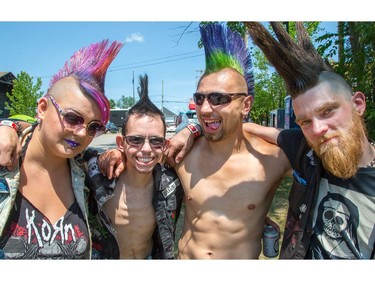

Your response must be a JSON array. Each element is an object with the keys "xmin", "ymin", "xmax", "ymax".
[{"xmin": 47, "ymin": 95, "xmax": 105, "ymax": 138}]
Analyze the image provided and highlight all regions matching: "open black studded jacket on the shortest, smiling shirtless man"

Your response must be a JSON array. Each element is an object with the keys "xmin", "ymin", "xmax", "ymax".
[{"xmin": 85, "ymin": 152, "xmax": 184, "ymax": 259}]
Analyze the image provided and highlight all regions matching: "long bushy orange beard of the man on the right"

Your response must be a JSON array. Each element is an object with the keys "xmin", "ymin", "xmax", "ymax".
[{"xmin": 310, "ymin": 109, "xmax": 366, "ymax": 179}]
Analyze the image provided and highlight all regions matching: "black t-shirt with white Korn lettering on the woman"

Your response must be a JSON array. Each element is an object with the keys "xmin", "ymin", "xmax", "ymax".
[{"xmin": 0, "ymin": 192, "xmax": 89, "ymax": 259}]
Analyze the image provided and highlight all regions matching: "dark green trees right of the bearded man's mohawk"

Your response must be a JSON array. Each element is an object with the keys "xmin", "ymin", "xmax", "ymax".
[{"xmin": 317, "ymin": 22, "xmax": 375, "ymax": 139}]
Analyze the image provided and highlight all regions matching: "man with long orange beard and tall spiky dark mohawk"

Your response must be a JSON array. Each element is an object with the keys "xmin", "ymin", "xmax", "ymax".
[{"xmin": 245, "ymin": 22, "xmax": 375, "ymax": 259}]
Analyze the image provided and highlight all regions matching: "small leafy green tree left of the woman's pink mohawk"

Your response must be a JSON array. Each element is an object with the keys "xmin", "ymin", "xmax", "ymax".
[{"xmin": 5, "ymin": 71, "xmax": 43, "ymax": 117}]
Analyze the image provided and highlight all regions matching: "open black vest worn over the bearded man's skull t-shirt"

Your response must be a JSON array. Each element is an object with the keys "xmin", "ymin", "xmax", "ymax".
[{"xmin": 277, "ymin": 129, "xmax": 322, "ymax": 259}]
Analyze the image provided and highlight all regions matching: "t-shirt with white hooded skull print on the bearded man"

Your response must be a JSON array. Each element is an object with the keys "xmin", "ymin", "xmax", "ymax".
[{"xmin": 310, "ymin": 168, "xmax": 375, "ymax": 259}]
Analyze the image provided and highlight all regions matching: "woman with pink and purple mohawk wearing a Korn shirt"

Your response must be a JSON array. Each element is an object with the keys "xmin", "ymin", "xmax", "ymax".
[{"xmin": 0, "ymin": 40, "xmax": 123, "ymax": 259}]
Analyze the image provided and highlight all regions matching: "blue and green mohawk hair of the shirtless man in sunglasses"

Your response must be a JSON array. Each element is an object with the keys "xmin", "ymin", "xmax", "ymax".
[{"xmin": 199, "ymin": 23, "xmax": 254, "ymax": 96}]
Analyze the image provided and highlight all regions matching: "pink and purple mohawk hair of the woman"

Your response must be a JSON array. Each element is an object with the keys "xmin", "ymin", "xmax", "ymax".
[{"xmin": 47, "ymin": 40, "xmax": 124, "ymax": 124}]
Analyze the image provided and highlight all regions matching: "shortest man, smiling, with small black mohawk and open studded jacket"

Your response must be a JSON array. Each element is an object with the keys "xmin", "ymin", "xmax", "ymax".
[{"xmin": 85, "ymin": 75, "xmax": 183, "ymax": 259}]
